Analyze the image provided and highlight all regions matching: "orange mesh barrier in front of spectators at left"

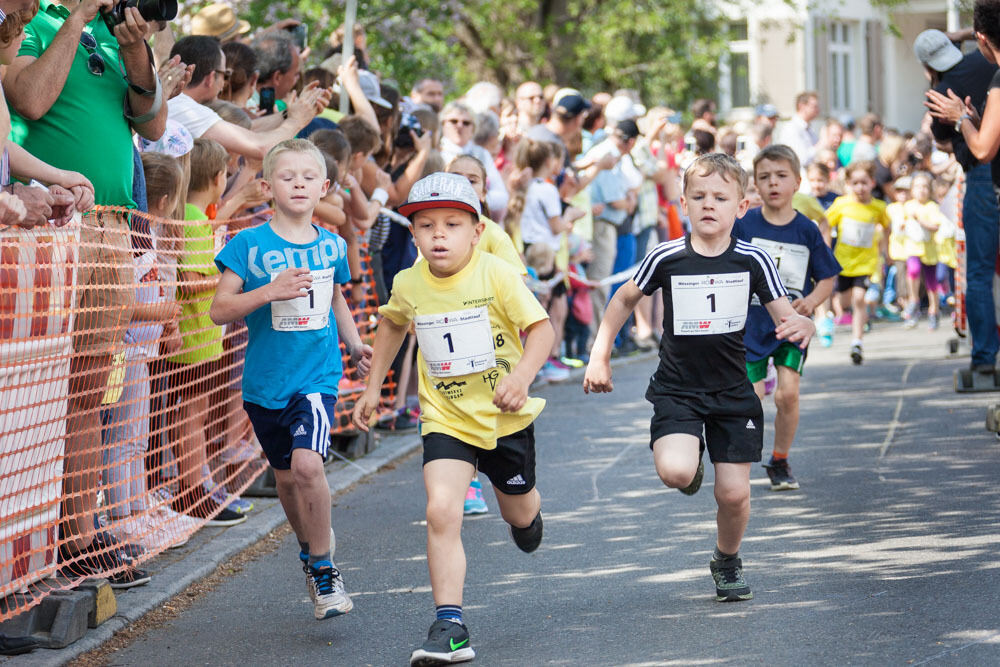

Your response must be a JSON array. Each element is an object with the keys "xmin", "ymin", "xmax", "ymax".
[{"xmin": 0, "ymin": 207, "xmax": 393, "ymax": 620}]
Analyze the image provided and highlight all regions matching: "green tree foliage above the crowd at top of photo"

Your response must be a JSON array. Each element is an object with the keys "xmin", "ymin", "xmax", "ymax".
[{"xmin": 178, "ymin": 0, "xmax": 725, "ymax": 104}]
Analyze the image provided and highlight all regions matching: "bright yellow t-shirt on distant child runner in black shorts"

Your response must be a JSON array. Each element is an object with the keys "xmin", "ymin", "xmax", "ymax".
[{"xmin": 826, "ymin": 195, "xmax": 889, "ymax": 277}]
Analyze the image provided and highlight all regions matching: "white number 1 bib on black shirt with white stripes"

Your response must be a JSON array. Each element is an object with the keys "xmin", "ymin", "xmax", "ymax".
[{"xmin": 670, "ymin": 272, "xmax": 750, "ymax": 336}]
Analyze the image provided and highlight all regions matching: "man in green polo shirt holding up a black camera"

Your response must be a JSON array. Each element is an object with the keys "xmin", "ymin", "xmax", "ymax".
[{"xmin": 4, "ymin": 0, "xmax": 168, "ymax": 587}]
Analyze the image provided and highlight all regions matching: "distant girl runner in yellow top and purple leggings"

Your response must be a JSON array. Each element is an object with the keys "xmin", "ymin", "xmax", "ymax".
[{"xmin": 903, "ymin": 171, "xmax": 945, "ymax": 331}]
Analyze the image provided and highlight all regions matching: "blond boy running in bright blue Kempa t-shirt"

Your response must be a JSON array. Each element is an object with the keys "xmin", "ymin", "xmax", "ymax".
[{"xmin": 210, "ymin": 139, "xmax": 372, "ymax": 619}]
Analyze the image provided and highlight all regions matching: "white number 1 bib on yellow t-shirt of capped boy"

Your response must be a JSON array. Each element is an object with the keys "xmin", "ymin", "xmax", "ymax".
[{"xmin": 413, "ymin": 306, "xmax": 497, "ymax": 377}]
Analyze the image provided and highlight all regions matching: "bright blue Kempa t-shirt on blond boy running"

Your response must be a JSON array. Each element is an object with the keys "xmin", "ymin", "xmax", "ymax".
[{"xmin": 215, "ymin": 222, "xmax": 351, "ymax": 410}]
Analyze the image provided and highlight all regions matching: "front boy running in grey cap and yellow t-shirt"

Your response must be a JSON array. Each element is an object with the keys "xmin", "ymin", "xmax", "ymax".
[{"xmin": 354, "ymin": 172, "xmax": 555, "ymax": 665}]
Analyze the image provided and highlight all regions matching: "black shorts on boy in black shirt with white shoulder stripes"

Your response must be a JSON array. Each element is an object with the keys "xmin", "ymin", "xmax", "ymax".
[{"xmin": 646, "ymin": 380, "xmax": 764, "ymax": 463}]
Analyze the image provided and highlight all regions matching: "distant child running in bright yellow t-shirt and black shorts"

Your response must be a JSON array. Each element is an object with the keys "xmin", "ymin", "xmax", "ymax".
[{"xmin": 826, "ymin": 160, "xmax": 889, "ymax": 365}]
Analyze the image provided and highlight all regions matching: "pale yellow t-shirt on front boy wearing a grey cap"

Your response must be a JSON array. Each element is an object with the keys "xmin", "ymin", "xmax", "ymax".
[{"xmin": 379, "ymin": 250, "xmax": 548, "ymax": 449}]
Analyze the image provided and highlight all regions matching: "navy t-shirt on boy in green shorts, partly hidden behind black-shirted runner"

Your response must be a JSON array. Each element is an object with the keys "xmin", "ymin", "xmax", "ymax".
[{"xmin": 733, "ymin": 207, "xmax": 840, "ymax": 361}]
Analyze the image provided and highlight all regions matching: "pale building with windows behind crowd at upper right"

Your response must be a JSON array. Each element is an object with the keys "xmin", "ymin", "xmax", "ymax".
[{"xmin": 719, "ymin": 0, "xmax": 975, "ymax": 130}]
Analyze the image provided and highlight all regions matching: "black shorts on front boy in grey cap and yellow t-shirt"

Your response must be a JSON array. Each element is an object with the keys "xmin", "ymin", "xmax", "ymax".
[{"xmin": 424, "ymin": 424, "xmax": 535, "ymax": 496}]
